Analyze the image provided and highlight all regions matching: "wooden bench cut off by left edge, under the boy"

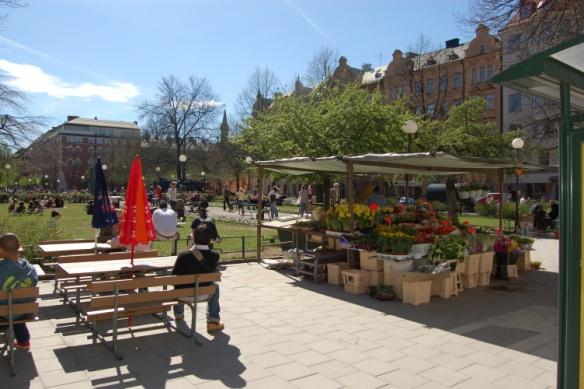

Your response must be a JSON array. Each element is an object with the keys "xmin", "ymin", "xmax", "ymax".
[{"xmin": 0, "ymin": 286, "xmax": 39, "ymax": 376}]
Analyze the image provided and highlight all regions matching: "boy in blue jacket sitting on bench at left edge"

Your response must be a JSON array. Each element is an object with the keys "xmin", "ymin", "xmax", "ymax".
[{"xmin": 0, "ymin": 233, "xmax": 39, "ymax": 350}]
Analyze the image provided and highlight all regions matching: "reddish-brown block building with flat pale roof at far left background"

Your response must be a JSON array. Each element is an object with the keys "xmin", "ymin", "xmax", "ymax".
[{"xmin": 21, "ymin": 116, "xmax": 140, "ymax": 190}]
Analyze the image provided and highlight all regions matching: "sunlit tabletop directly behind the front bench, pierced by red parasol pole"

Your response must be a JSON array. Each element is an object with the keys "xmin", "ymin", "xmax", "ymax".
[{"xmin": 57, "ymin": 255, "xmax": 176, "ymax": 277}]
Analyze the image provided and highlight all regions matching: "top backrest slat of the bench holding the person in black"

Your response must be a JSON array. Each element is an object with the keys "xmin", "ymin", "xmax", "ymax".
[{"xmin": 87, "ymin": 272, "xmax": 221, "ymax": 293}]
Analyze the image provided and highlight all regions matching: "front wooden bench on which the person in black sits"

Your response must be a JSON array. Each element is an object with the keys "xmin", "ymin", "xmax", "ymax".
[{"xmin": 80, "ymin": 272, "xmax": 221, "ymax": 359}]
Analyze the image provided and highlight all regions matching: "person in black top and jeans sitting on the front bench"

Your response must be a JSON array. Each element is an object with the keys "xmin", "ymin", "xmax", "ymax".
[{"xmin": 172, "ymin": 222, "xmax": 225, "ymax": 332}]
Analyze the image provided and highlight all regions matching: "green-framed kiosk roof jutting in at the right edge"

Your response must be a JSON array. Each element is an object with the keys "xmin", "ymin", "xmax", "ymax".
[{"xmin": 492, "ymin": 35, "xmax": 584, "ymax": 110}]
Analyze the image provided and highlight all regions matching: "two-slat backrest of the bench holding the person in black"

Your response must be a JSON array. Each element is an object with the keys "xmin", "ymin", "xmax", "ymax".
[{"xmin": 87, "ymin": 272, "xmax": 221, "ymax": 308}]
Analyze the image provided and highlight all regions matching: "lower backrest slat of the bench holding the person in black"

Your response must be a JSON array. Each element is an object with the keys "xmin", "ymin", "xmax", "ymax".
[{"xmin": 89, "ymin": 285, "xmax": 215, "ymax": 308}]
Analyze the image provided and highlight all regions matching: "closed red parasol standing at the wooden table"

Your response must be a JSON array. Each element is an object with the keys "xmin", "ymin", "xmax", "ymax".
[{"xmin": 120, "ymin": 155, "xmax": 156, "ymax": 265}]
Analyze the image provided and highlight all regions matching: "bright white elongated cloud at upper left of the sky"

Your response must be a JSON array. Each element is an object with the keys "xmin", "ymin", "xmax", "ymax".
[{"xmin": 0, "ymin": 60, "xmax": 140, "ymax": 103}]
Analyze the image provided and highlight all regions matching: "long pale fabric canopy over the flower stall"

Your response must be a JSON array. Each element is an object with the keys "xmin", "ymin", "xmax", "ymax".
[{"xmin": 255, "ymin": 152, "xmax": 545, "ymax": 175}]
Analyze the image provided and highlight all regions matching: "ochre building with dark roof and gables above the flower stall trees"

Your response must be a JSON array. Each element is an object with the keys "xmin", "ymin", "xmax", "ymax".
[{"xmin": 362, "ymin": 25, "xmax": 500, "ymax": 122}]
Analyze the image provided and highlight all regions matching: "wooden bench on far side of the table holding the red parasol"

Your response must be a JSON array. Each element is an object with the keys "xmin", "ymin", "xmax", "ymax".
[{"xmin": 53, "ymin": 250, "xmax": 158, "ymax": 304}]
